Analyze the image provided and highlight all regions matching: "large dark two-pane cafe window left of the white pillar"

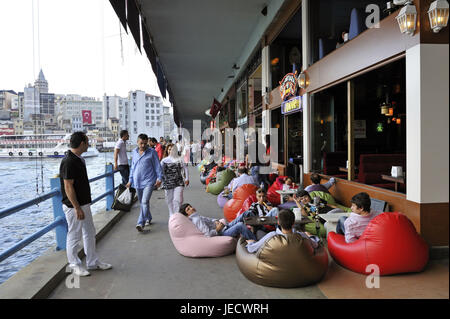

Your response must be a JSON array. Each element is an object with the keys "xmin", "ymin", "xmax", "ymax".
[{"xmin": 311, "ymin": 58, "xmax": 406, "ymax": 192}]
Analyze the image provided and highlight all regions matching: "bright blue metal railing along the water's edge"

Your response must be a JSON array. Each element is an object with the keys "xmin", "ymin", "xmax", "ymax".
[{"xmin": 0, "ymin": 163, "xmax": 119, "ymax": 262}]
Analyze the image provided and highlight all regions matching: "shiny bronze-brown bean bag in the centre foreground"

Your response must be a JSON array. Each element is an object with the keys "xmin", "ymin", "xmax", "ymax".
[{"xmin": 236, "ymin": 234, "xmax": 328, "ymax": 288}]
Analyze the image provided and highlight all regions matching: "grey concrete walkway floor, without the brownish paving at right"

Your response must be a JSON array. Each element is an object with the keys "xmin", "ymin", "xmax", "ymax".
[{"xmin": 50, "ymin": 167, "xmax": 325, "ymax": 299}]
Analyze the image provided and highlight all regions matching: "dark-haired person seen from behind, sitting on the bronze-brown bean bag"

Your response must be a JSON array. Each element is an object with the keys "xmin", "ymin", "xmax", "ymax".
[{"xmin": 247, "ymin": 209, "xmax": 320, "ymax": 253}]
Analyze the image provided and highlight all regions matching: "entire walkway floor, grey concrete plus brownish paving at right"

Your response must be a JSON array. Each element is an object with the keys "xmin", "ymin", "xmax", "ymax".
[{"xmin": 50, "ymin": 167, "xmax": 449, "ymax": 299}]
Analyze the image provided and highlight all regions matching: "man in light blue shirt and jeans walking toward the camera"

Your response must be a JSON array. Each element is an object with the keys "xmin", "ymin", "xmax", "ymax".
[{"xmin": 127, "ymin": 134, "xmax": 162, "ymax": 232}]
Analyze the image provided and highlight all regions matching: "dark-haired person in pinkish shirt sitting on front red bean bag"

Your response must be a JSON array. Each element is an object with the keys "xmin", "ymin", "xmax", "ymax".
[{"xmin": 336, "ymin": 193, "xmax": 379, "ymax": 243}]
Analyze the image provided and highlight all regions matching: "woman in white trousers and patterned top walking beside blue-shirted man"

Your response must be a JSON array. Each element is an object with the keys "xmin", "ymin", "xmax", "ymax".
[{"xmin": 161, "ymin": 145, "xmax": 189, "ymax": 216}]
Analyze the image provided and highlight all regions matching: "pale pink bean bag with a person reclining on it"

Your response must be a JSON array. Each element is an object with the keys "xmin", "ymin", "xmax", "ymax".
[{"xmin": 169, "ymin": 213, "xmax": 237, "ymax": 257}]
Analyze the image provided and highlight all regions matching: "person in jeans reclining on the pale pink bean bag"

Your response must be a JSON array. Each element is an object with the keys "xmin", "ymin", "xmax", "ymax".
[{"xmin": 179, "ymin": 203, "xmax": 256, "ymax": 240}]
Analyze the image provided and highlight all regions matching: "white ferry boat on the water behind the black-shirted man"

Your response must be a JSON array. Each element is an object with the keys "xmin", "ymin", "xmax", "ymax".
[{"xmin": 0, "ymin": 134, "xmax": 99, "ymax": 159}]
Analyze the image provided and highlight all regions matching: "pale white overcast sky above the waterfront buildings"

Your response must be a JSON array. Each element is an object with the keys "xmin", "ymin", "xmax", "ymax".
[{"xmin": 0, "ymin": 0, "xmax": 165, "ymax": 105}]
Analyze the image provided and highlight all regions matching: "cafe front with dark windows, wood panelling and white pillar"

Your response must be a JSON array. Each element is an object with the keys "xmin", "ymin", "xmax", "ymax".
[{"xmin": 217, "ymin": 0, "xmax": 449, "ymax": 246}]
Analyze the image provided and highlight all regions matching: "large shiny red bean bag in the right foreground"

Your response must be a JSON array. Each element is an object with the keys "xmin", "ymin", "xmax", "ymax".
[{"xmin": 328, "ymin": 212, "xmax": 428, "ymax": 275}]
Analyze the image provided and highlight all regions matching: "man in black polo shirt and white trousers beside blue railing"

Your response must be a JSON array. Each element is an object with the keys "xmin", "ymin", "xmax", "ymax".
[{"xmin": 59, "ymin": 132, "xmax": 112, "ymax": 276}]
